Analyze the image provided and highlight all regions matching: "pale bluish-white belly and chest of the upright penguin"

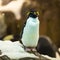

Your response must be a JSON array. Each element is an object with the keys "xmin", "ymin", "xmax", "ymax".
[{"xmin": 22, "ymin": 17, "xmax": 39, "ymax": 47}]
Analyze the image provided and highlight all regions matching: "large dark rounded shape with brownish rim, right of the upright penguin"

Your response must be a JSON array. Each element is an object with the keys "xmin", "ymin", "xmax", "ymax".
[{"xmin": 36, "ymin": 36, "xmax": 59, "ymax": 58}]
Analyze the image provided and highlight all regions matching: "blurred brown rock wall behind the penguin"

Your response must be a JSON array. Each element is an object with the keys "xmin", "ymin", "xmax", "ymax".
[{"xmin": 0, "ymin": 0, "xmax": 60, "ymax": 47}]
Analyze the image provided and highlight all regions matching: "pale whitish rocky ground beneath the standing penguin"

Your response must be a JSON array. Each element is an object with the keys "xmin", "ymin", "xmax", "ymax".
[{"xmin": 0, "ymin": 41, "xmax": 60, "ymax": 60}]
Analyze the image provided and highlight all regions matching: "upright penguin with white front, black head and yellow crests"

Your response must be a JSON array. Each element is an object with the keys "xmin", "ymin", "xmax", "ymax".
[{"xmin": 20, "ymin": 10, "xmax": 40, "ymax": 48}]
